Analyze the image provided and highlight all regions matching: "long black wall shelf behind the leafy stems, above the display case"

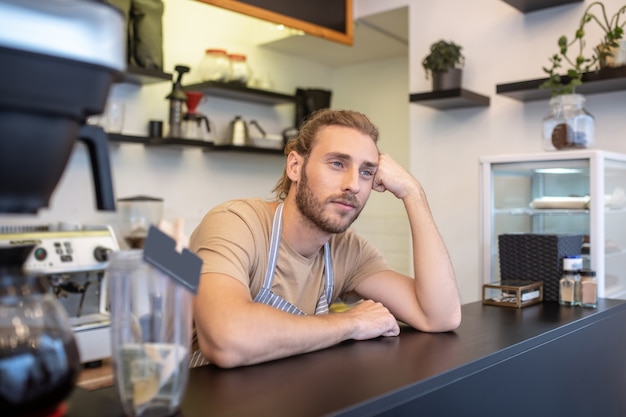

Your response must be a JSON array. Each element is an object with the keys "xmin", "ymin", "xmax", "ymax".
[{"xmin": 496, "ymin": 66, "xmax": 626, "ymax": 101}]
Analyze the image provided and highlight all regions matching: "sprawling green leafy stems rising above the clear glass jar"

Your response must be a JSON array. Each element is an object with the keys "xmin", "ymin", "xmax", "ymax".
[{"xmin": 540, "ymin": 1, "xmax": 626, "ymax": 97}]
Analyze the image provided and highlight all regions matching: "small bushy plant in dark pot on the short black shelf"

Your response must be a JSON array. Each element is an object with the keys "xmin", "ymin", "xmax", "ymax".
[{"xmin": 422, "ymin": 40, "xmax": 465, "ymax": 90}]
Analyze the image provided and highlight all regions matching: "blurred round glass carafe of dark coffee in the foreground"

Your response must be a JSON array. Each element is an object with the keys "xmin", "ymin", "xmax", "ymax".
[{"xmin": 0, "ymin": 244, "xmax": 80, "ymax": 417}]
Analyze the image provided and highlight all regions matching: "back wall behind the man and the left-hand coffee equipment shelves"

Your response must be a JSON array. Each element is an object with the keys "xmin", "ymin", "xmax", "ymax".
[{"xmin": 0, "ymin": 0, "xmax": 410, "ymax": 272}]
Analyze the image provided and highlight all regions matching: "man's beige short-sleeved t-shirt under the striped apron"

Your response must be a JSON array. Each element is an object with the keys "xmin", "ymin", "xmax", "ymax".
[{"xmin": 189, "ymin": 199, "xmax": 390, "ymax": 314}]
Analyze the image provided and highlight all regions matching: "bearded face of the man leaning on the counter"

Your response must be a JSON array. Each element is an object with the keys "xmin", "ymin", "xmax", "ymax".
[{"xmin": 296, "ymin": 126, "xmax": 378, "ymax": 233}]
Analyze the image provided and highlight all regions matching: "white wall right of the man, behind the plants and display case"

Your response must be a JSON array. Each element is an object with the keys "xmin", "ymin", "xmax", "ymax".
[{"xmin": 409, "ymin": 0, "xmax": 626, "ymax": 302}]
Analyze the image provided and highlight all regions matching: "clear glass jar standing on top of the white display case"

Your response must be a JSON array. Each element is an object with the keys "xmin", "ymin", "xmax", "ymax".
[{"xmin": 543, "ymin": 94, "xmax": 595, "ymax": 151}]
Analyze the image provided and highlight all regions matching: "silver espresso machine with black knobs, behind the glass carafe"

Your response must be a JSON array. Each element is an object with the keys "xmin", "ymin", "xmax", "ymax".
[{"xmin": 0, "ymin": 223, "xmax": 119, "ymax": 366}]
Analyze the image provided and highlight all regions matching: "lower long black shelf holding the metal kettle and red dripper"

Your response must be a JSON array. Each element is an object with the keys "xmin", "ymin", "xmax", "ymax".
[{"xmin": 108, "ymin": 133, "xmax": 283, "ymax": 155}]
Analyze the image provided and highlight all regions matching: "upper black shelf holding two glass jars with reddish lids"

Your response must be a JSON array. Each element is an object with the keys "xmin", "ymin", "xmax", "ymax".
[{"xmin": 183, "ymin": 81, "xmax": 296, "ymax": 105}]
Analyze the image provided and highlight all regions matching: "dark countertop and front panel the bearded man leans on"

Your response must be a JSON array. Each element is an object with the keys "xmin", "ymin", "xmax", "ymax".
[{"xmin": 67, "ymin": 300, "xmax": 626, "ymax": 417}]
